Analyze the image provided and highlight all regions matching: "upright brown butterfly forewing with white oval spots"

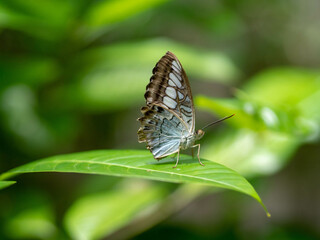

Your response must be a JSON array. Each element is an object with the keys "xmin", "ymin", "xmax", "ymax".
[{"xmin": 145, "ymin": 52, "xmax": 195, "ymax": 133}]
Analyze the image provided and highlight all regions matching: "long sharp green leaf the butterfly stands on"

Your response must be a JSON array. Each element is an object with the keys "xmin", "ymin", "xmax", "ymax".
[{"xmin": 0, "ymin": 150, "xmax": 268, "ymax": 213}]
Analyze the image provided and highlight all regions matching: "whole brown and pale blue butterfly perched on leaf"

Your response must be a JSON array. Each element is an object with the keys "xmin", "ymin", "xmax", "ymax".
[{"xmin": 138, "ymin": 52, "xmax": 233, "ymax": 167}]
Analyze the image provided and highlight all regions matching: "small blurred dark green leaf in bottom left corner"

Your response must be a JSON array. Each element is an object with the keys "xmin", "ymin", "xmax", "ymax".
[{"xmin": 4, "ymin": 206, "xmax": 56, "ymax": 239}]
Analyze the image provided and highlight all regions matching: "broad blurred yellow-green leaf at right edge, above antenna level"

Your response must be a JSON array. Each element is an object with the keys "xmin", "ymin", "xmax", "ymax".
[{"xmin": 237, "ymin": 68, "xmax": 320, "ymax": 140}]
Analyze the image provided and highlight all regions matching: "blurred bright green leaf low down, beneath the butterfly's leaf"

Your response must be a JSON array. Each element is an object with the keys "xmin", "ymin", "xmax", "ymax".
[{"xmin": 65, "ymin": 179, "xmax": 166, "ymax": 239}]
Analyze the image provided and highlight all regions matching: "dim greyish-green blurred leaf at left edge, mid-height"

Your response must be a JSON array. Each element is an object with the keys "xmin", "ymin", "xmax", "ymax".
[{"xmin": 0, "ymin": 84, "xmax": 54, "ymax": 151}]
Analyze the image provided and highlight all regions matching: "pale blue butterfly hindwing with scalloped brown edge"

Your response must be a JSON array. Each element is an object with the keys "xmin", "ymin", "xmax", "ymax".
[{"xmin": 138, "ymin": 105, "xmax": 188, "ymax": 159}]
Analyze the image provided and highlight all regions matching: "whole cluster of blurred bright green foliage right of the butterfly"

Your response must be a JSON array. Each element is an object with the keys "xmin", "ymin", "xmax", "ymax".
[{"xmin": 196, "ymin": 66, "xmax": 320, "ymax": 175}]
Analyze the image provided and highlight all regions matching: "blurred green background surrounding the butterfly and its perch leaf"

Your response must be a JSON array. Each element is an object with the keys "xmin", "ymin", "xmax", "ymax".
[{"xmin": 0, "ymin": 0, "xmax": 320, "ymax": 240}]
